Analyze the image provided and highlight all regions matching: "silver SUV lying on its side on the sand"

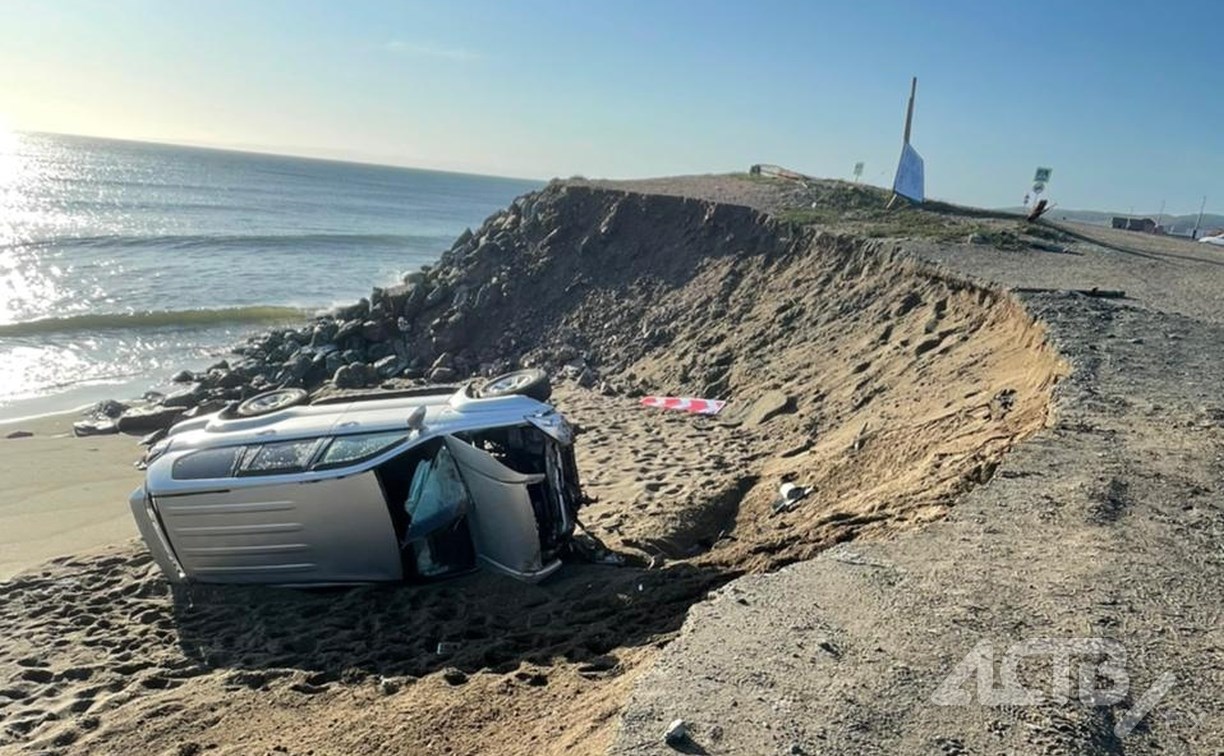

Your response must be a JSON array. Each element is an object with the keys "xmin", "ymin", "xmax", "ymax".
[{"xmin": 131, "ymin": 371, "xmax": 584, "ymax": 585}]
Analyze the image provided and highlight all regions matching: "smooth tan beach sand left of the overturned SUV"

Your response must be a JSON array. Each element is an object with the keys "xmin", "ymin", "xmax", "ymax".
[{"xmin": 0, "ymin": 413, "xmax": 142, "ymax": 580}]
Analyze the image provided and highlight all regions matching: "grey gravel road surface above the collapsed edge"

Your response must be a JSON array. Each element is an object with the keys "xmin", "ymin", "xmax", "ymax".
[{"xmin": 612, "ymin": 179, "xmax": 1224, "ymax": 755}]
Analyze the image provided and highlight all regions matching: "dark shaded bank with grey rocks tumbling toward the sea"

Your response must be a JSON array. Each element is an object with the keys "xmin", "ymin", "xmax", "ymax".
[{"xmin": 86, "ymin": 182, "xmax": 794, "ymax": 432}]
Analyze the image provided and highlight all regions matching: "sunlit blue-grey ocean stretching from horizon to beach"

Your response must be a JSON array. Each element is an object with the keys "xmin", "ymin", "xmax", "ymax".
[{"xmin": 0, "ymin": 133, "xmax": 541, "ymax": 421}]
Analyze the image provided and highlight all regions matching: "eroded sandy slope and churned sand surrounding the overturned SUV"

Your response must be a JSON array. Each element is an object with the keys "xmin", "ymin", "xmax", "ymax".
[{"xmin": 0, "ymin": 179, "xmax": 1065, "ymax": 754}]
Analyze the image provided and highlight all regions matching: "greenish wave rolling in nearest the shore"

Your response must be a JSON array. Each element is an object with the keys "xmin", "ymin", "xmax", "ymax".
[{"xmin": 0, "ymin": 305, "xmax": 313, "ymax": 338}]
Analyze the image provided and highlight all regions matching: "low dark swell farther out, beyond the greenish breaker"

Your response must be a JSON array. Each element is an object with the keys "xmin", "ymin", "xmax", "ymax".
[{"xmin": 0, "ymin": 234, "xmax": 450, "ymax": 251}]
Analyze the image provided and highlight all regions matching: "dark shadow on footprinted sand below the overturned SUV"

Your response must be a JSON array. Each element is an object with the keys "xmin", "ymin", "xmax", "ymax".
[{"xmin": 166, "ymin": 555, "xmax": 736, "ymax": 692}]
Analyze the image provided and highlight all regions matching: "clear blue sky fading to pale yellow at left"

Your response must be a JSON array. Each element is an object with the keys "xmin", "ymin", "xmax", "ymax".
[{"xmin": 0, "ymin": 0, "xmax": 1224, "ymax": 213}]
